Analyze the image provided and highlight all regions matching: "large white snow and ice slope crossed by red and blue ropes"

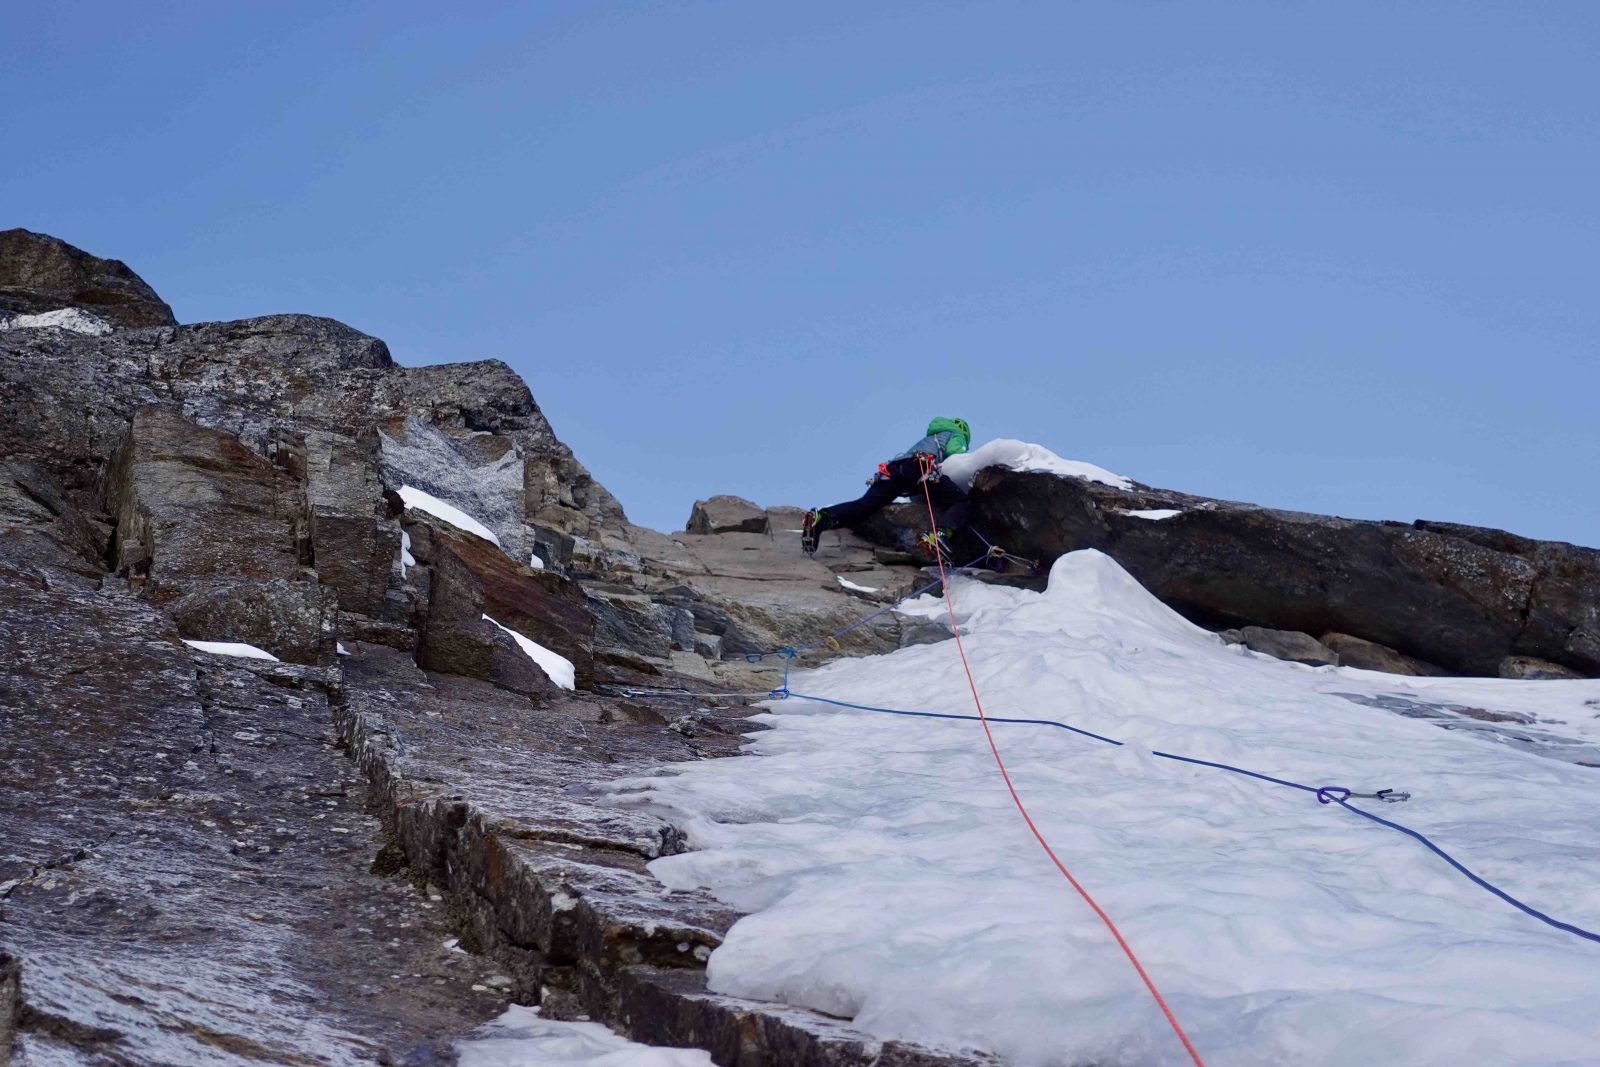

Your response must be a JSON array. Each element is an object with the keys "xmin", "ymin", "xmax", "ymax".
[{"xmin": 611, "ymin": 550, "xmax": 1600, "ymax": 1067}]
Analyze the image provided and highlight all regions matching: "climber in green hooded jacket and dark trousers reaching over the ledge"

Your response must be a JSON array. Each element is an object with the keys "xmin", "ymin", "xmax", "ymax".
[{"xmin": 800, "ymin": 418, "xmax": 973, "ymax": 560}]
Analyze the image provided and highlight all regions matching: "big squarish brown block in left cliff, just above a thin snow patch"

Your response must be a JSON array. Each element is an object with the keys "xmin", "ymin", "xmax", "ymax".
[{"xmin": 106, "ymin": 406, "xmax": 336, "ymax": 664}]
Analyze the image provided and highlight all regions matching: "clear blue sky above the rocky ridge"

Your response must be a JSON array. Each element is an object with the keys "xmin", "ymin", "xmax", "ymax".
[{"xmin": 0, "ymin": 0, "xmax": 1600, "ymax": 545}]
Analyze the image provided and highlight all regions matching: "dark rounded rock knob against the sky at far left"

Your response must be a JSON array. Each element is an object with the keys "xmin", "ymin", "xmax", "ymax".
[{"xmin": 0, "ymin": 229, "xmax": 178, "ymax": 326}]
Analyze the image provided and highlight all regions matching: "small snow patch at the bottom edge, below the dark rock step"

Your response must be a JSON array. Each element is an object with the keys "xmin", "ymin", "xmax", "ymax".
[{"xmin": 456, "ymin": 1005, "xmax": 712, "ymax": 1067}]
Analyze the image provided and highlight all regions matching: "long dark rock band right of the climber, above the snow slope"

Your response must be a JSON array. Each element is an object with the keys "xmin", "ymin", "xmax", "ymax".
[{"xmin": 864, "ymin": 467, "xmax": 1600, "ymax": 677}]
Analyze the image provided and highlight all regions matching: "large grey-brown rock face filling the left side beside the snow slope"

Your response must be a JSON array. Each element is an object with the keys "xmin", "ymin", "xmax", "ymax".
[{"xmin": 0, "ymin": 231, "xmax": 978, "ymax": 1067}]
